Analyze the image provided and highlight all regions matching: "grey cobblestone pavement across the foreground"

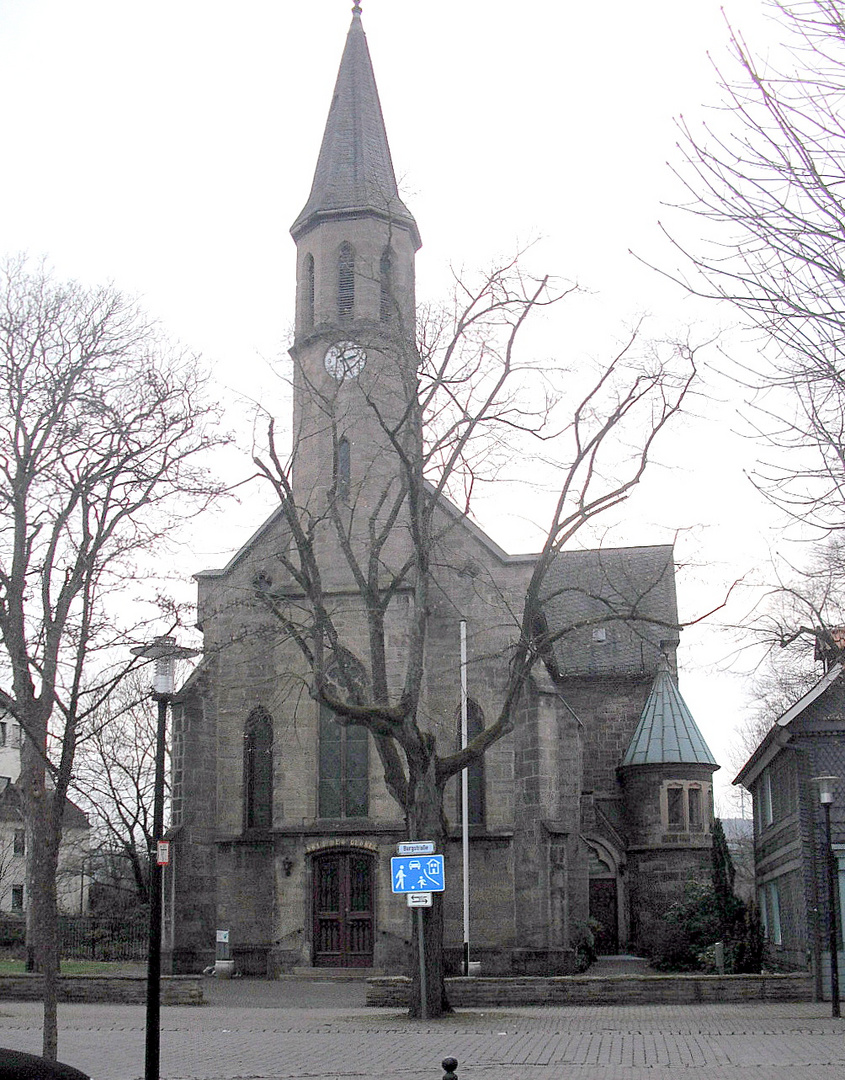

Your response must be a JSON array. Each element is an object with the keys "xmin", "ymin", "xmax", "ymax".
[{"xmin": 0, "ymin": 993, "xmax": 845, "ymax": 1080}]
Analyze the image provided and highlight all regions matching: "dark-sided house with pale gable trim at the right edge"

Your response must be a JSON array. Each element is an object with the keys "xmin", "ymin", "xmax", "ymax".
[{"xmin": 734, "ymin": 662, "xmax": 845, "ymax": 982}]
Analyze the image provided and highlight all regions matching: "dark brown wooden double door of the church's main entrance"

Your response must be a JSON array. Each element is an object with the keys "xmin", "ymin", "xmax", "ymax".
[{"xmin": 311, "ymin": 851, "xmax": 375, "ymax": 968}]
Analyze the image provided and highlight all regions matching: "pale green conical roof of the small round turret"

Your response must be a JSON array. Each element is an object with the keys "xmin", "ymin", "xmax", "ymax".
[{"xmin": 622, "ymin": 661, "xmax": 719, "ymax": 768}]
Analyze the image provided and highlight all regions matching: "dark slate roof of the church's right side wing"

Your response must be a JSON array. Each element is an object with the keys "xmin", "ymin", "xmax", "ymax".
[{"xmin": 544, "ymin": 544, "xmax": 679, "ymax": 676}]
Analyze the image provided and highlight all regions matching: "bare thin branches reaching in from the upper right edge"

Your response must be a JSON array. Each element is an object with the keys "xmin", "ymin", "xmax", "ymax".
[{"xmin": 674, "ymin": 0, "xmax": 845, "ymax": 532}]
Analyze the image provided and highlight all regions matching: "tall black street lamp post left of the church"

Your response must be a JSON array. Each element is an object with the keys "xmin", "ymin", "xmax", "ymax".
[{"xmin": 132, "ymin": 635, "xmax": 197, "ymax": 1080}]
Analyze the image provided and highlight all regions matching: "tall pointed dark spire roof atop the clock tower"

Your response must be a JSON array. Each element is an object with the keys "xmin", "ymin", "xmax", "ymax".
[{"xmin": 291, "ymin": 4, "xmax": 421, "ymax": 247}]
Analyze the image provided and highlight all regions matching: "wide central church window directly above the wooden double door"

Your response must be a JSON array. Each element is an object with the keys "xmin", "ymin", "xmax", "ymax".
[{"xmin": 318, "ymin": 705, "xmax": 370, "ymax": 818}]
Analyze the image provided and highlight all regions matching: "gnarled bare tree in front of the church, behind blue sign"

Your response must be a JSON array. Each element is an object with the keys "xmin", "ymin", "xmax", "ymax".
[{"xmin": 249, "ymin": 262, "xmax": 695, "ymax": 1015}]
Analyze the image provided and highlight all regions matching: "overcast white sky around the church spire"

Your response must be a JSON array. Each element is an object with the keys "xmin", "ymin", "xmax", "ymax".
[{"xmin": 0, "ymin": 0, "xmax": 786, "ymax": 812}]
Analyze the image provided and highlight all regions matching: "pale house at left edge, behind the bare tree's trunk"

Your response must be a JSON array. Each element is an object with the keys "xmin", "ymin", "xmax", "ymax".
[{"xmin": 0, "ymin": 715, "xmax": 91, "ymax": 915}]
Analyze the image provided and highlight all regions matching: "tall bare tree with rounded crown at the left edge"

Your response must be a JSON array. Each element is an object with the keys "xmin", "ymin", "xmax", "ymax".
[{"xmin": 0, "ymin": 259, "xmax": 224, "ymax": 1058}]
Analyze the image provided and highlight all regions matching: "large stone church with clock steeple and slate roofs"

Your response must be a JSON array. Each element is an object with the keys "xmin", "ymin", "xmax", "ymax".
[{"xmin": 165, "ymin": 5, "xmax": 717, "ymax": 974}]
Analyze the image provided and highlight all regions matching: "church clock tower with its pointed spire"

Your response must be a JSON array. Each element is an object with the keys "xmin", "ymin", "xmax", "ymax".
[{"xmin": 291, "ymin": 3, "xmax": 420, "ymax": 518}]
